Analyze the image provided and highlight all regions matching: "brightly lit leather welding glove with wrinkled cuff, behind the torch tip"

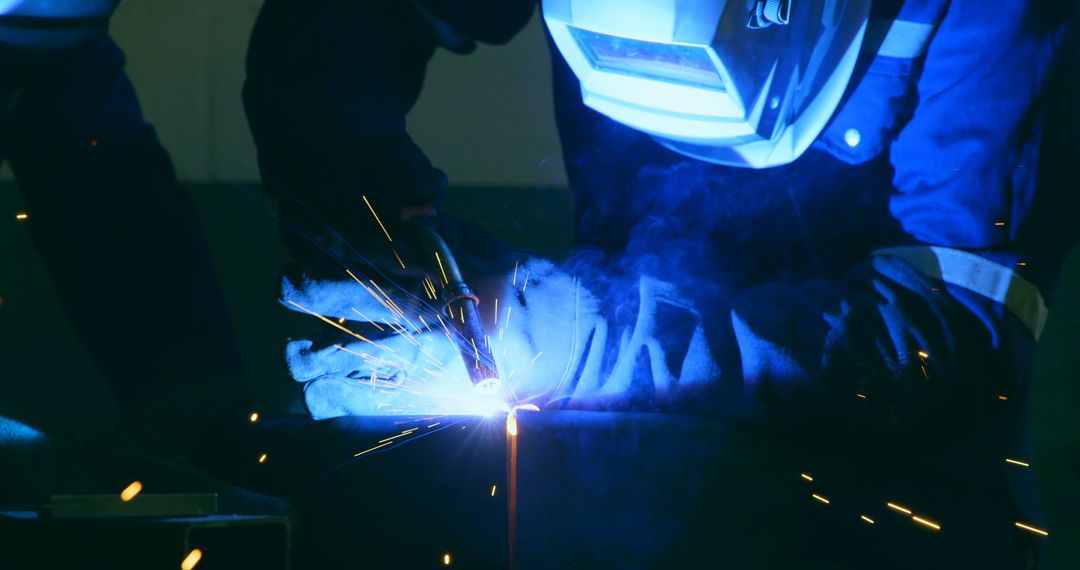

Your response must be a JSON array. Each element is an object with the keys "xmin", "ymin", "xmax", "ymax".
[{"xmin": 282, "ymin": 260, "xmax": 717, "ymax": 419}]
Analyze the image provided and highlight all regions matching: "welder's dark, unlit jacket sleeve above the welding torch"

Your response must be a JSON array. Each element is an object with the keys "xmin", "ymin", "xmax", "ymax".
[{"xmin": 244, "ymin": 0, "xmax": 446, "ymax": 219}]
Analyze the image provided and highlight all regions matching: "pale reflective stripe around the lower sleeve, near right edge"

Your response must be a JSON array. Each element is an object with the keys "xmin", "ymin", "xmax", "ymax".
[{"xmin": 875, "ymin": 246, "xmax": 1050, "ymax": 340}]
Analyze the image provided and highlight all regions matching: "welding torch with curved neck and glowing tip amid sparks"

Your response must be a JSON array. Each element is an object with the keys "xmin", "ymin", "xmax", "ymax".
[{"xmin": 405, "ymin": 216, "xmax": 501, "ymax": 394}]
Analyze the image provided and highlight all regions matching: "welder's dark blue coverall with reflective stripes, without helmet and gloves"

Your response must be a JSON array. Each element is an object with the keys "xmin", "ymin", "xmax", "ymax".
[{"xmin": 244, "ymin": 0, "xmax": 1078, "ymax": 568}]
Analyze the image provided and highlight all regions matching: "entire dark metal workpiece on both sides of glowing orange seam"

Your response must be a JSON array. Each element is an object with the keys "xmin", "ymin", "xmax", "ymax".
[{"xmin": 235, "ymin": 410, "xmax": 807, "ymax": 569}]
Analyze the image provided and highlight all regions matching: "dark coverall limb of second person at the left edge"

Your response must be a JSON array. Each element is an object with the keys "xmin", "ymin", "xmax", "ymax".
[{"xmin": 0, "ymin": 0, "xmax": 248, "ymax": 440}]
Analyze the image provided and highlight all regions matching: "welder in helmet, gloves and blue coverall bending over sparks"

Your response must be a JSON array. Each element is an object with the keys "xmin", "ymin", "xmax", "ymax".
[{"xmin": 244, "ymin": 0, "xmax": 1077, "ymax": 568}]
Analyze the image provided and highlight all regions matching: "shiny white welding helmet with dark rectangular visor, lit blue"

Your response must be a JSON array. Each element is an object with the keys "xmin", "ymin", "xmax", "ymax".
[{"xmin": 543, "ymin": 0, "xmax": 870, "ymax": 168}]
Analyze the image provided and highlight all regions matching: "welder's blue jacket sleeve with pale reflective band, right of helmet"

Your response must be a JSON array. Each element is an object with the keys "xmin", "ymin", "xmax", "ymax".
[{"xmin": 731, "ymin": 0, "xmax": 1061, "ymax": 438}]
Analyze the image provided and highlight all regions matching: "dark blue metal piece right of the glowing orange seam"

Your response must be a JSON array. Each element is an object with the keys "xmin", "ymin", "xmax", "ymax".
[{"xmin": 507, "ymin": 411, "xmax": 805, "ymax": 569}]
